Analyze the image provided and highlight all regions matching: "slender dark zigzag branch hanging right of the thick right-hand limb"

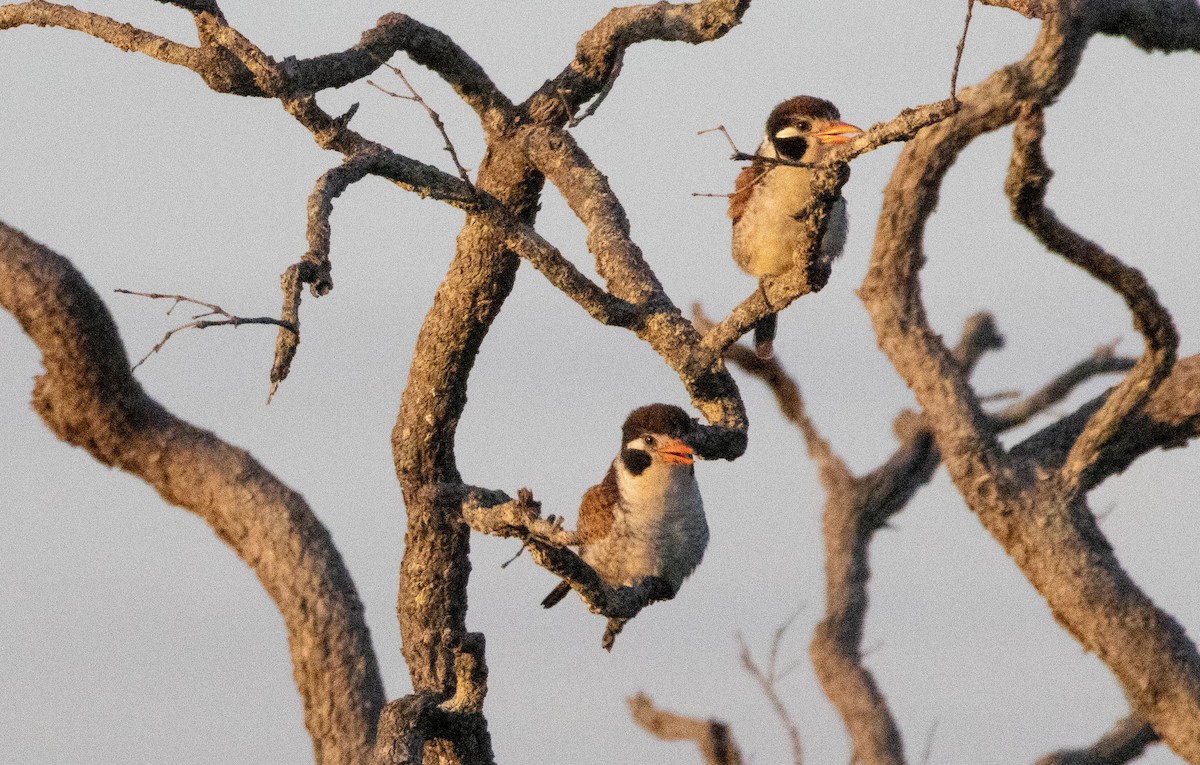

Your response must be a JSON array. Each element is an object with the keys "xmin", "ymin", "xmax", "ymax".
[{"xmin": 1004, "ymin": 104, "xmax": 1180, "ymax": 484}]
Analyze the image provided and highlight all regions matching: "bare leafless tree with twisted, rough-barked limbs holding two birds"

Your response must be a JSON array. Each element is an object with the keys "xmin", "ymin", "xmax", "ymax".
[{"xmin": 0, "ymin": 0, "xmax": 1200, "ymax": 764}]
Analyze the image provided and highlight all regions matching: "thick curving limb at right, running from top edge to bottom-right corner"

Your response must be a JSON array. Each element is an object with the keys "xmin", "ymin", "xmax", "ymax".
[{"xmin": 859, "ymin": 0, "xmax": 1200, "ymax": 761}]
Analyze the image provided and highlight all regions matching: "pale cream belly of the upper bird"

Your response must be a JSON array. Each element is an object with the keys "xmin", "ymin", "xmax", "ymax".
[{"xmin": 733, "ymin": 168, "xmax": 848, "ymax": 277}]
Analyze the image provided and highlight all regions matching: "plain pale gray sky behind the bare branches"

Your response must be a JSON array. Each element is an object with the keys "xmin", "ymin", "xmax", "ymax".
[{"xmin": 0, "ymin": 0, "xmax": 1200, "ymax": 765}]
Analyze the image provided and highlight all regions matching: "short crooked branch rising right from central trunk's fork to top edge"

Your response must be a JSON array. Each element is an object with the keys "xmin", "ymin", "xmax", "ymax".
[{"xmin": 526, "ymin": 0, "xmax": 750, "ymax": 126}]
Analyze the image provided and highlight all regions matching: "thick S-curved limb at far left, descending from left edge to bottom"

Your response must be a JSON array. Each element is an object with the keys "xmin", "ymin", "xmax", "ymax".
[{"xmin": 0, "ymin": 224, "xmax": 384, "ymax": 765}]
